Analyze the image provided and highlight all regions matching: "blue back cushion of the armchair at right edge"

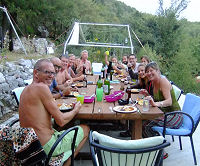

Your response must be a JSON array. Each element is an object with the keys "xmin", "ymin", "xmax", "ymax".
[{"xmin": 182, "ymin": 93, "xmax": 200, "ymax": 129}]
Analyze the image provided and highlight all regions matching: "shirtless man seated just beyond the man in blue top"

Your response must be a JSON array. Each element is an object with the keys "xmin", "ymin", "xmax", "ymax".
[{"xmin": 56, "ymin": 55, "xmax": 73, "ymax": 86}]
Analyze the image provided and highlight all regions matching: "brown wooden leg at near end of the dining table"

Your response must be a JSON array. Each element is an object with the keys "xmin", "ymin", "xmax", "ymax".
[{"xmin": 131, "ymin": 119, "xmax": 142, "ymax": 139}]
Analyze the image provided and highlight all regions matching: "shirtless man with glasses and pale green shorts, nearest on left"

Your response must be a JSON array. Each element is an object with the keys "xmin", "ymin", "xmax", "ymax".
[{"xmin": 19, "ymin": 59, "xmax": 89, "ymax": 166}]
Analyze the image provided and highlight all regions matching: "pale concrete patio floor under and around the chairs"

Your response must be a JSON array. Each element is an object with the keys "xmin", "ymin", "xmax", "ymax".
[{"xmin": 75, "ymin": 95, "xmax": 200, "ymax": 166}]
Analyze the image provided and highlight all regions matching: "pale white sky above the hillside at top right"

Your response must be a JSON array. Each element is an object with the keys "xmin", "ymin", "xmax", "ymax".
[{"xmin": 118, "ymin": 0, "xmax": 200, "ymax": 22}]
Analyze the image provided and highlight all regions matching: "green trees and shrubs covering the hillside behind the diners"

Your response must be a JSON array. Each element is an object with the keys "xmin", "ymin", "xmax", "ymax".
[{"xmin": 0, "ymin": 0, "xmax": 200, "ymax": 94}]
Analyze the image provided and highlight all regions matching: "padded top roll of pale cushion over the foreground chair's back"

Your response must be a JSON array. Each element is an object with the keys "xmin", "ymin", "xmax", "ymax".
[{"xmin": 92, "ymin": 131, "xmax": 164, "ymax": 149}]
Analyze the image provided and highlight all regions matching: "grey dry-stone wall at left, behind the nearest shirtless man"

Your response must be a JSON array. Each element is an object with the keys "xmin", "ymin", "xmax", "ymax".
[{"xmin": 0, "ymin": 59, "xmax": 36, "ymax": 117}]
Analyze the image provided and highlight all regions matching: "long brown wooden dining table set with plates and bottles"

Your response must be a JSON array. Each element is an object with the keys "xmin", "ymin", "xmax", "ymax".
[{"xmin": 56, "ymin": 75, "xmax": 163, "ymax": 139}]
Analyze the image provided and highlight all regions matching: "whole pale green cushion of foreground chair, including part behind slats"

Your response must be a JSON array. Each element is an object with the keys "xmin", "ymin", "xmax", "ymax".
[{"xmin": 92, "ymin": 131, "xmax": 164, "ymax": 166}]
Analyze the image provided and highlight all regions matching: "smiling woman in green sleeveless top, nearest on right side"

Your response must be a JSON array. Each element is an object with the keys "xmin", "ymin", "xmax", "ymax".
[{"xmin": 143, "ymin": 62, "xmax": 183, "ymax": 137}]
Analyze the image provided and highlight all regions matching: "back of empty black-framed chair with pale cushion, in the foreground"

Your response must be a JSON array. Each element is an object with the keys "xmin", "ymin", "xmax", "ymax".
[{"xmin": 90, "ymin": 131, "xmax": 170, "ymax": 166}]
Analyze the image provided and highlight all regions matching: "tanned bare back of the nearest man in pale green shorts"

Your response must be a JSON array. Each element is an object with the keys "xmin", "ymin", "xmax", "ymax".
[{"xmin": 19, "ymin": 83, "xmax": 53, "ymax": 145}]
